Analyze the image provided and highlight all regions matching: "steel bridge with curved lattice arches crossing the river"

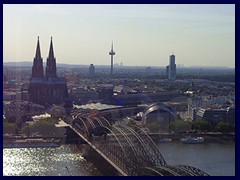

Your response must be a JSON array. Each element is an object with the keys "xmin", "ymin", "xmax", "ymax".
[{"xmin": 67, "ymin": 109, "xmax": 208, "ymax": 176}]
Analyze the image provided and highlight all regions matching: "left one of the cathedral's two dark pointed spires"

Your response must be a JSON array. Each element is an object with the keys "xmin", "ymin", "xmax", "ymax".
[{"xmin": 32, "ymin": 37, "xmax": 44, "ymax": 78}]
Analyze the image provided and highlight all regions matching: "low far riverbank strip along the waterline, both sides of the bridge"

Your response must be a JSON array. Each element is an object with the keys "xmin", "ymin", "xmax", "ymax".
[{"xmin": 3, "ymin": 132, "xmax": 235, "ymax": 148}]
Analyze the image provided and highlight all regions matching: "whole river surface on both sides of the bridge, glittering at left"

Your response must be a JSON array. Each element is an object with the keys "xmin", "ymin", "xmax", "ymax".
[{"xmin": 3, "ymin": 142, "xmax": 235, "ymax": 176}]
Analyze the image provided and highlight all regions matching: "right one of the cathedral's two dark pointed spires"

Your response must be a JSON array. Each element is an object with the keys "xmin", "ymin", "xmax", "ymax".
[{"xmin": 46, "ymin": 37, "xmax": 57, "ymax": 78}]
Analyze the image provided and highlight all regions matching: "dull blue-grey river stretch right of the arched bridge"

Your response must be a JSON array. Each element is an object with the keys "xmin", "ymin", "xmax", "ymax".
[{"xmin": 158, "ymin": 142, "xmax": 235, "ymax": 176}]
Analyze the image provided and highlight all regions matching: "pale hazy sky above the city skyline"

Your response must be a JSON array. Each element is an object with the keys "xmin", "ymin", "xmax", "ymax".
[{"xmin": 3, "ymin": 4, "xmax": 235, "ymax": 67}]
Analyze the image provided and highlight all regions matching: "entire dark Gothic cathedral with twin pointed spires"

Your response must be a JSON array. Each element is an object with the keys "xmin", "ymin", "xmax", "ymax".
[{"xmin": 28, "ymin": 37, "xmax": 68, "ymax": 106}]
